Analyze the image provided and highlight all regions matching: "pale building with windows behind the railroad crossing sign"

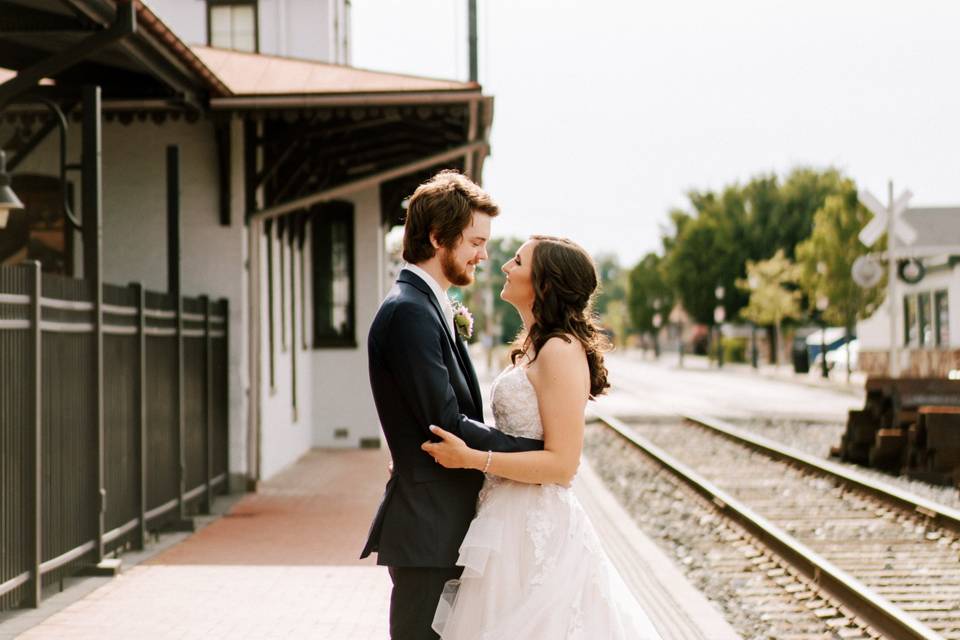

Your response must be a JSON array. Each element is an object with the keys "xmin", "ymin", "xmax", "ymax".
[{"xmin": 857, "ymin": 207, "xmax": 960, "ymax": 377}]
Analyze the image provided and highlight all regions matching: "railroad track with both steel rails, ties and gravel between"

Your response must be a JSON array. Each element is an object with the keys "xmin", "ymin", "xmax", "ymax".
[{"xmin": 597, "ymin": 414, "xmax": 960, "ymax": 640}]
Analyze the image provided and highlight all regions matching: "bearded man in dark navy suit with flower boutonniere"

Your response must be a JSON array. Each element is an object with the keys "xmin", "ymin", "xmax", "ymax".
[{"xmin": 360, "ymin": 171, "xmax": 543, "ymax": 640}]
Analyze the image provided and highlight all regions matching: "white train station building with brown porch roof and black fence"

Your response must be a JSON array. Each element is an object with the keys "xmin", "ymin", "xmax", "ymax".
[{"xmin": 0, "ymin": 0, "xmax": 493, "ymax": 606}]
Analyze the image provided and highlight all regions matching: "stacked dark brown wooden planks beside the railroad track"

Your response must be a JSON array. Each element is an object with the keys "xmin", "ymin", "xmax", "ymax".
[{"xmin": 834, "ymin": 378, "xmax": 960, "ymax": 486}]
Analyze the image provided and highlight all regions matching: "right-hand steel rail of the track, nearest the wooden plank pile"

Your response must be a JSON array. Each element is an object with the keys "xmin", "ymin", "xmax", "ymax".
[{"xmin": 682, "ymin": 415, "xmax": 960, "ymax": 534}]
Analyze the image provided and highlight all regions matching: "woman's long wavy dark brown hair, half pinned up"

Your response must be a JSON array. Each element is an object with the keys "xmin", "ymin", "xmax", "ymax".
[{"xmin": 510, "ymin": 236, "xmax": 610, "ymax": 397}]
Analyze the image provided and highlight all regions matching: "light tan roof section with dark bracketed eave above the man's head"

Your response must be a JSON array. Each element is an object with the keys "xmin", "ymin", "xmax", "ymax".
[{"xmin": 193, "ymin": 46, "xmax": 493, "ymax": 230}]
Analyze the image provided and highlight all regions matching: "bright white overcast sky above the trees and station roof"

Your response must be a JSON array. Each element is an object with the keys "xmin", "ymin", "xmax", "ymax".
[{"xmin": 352, "ymin": 0, "xmax": 960, "ymax": 265}]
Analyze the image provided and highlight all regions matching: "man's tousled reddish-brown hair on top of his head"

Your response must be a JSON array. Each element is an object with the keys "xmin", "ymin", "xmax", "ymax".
[{"xmin": 403, "ymin": 170, "xmax": 500, "ymax": 264}]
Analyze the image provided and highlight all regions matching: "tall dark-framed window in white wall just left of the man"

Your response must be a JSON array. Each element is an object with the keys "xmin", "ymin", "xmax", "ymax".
[{"xmin": 310, "ymin": 202, "xmax": 357, "ymax": 348}]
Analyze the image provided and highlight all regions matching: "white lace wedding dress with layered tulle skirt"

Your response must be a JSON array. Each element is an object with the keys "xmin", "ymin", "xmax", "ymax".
[{"xmin": 433, "ymin": 367, "xmax": 660, "ymax": 640}]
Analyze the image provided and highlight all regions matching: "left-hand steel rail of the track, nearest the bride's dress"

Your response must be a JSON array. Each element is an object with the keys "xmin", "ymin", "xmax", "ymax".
[{"xmin": 592, "ymin": 410, "xmax": 943, "ymax": 640}]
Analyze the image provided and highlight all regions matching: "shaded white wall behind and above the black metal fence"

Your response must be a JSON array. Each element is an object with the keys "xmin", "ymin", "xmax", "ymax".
[{"xmin": 0, "ymin": 119, "xmax": 247, "ymax": 482}]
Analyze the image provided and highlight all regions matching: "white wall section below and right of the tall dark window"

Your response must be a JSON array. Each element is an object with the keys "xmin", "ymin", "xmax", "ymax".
[{"xmin": 311, "ymin": 188, "xmax": 384, "ymax": 447}]
